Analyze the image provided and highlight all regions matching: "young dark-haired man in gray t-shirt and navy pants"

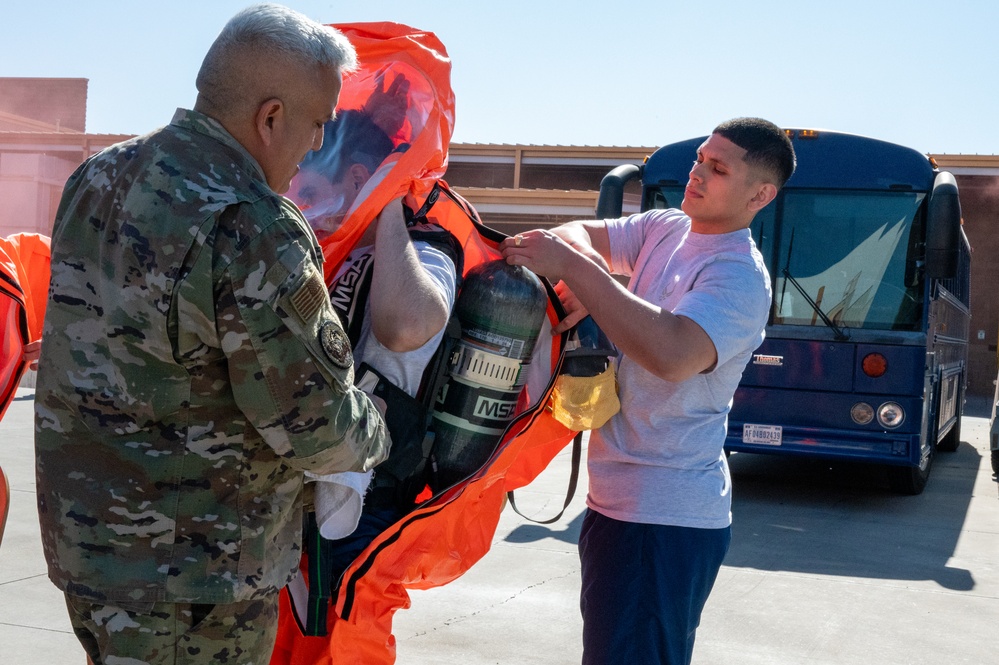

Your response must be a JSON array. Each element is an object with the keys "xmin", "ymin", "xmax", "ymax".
[{"xmin": 501, "ymin": 118, "xmax": 795, "ymax": 665}]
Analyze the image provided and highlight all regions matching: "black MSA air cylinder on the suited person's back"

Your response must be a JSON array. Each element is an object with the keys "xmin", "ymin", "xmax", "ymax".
[{"xmin": 433, "ymin": 260, "xmax": 548, "ymax": 488}]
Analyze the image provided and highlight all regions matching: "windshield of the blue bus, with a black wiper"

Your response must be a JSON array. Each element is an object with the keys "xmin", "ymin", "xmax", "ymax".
[{"xmin": 768, "ymin": 190, "xmax": 925, "ymax": 330}]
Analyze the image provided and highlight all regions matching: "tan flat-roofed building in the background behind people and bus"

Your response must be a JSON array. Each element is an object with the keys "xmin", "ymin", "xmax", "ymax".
[{"xmin": 0, "ymin": 79, "xmax": 999, "ymax": 397}]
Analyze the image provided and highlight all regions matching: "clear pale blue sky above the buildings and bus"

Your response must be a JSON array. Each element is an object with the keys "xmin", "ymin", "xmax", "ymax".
[{"xmin": 0, "ymin": 0, "xmax": 999, "ymax": 154}]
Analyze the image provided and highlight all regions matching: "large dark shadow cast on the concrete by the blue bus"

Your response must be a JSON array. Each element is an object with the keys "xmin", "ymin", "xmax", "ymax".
[{"xmin": 725, "ymin": 443, "xmax": 981, "ymax": 591}]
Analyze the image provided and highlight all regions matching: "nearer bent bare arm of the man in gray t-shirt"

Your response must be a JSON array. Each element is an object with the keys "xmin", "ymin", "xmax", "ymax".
[{"xmin": 501, "ymin": 222, "xmax": 718, "ymax": 382}]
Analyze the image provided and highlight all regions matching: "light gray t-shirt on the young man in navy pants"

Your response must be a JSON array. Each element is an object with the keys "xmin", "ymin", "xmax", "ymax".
[{"xmin": 587, "ymin": 210, "xmax": 771, "ymax": 529}]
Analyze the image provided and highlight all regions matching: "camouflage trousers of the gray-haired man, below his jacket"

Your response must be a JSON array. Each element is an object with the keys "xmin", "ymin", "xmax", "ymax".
[{"xmin": 66, "ymin": 592, "xmax": 278, "ymax": 665}]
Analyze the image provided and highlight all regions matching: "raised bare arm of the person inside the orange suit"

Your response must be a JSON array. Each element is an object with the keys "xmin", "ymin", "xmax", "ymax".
[{"xmin": 368, "ymin": 200, "xmax": 449, "ymax": 352}]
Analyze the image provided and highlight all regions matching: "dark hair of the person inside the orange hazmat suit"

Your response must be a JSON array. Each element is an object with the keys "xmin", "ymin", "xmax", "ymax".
[{"xmin": 301, "ymin": 109, "xmax": 395, "ymax": 183}]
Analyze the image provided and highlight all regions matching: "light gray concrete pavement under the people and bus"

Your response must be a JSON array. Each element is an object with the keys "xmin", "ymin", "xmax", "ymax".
[{"xmin": 0, "ymin": 389, "xmax": 999, "ymax": 665}]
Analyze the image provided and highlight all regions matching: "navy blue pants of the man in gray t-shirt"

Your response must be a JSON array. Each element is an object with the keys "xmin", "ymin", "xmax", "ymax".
[{"xmin": 579, "ymin": 509, "xmax": 732, "ymax": 665}]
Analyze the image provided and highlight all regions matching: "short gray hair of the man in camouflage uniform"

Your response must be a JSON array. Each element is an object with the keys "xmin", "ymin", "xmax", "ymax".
[{"xmin": 197, "ymin": 3, "xmax": 358, "ymax": 106}]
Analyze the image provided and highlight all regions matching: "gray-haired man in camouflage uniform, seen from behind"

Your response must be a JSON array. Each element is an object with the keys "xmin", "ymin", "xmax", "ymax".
[{"xmin": 35, "ymin": 5, "xmax": 388, "ymax": 664}]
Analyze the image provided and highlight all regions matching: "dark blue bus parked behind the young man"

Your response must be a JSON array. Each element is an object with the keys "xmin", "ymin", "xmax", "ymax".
[{"xmin": 597, "ymin": 129, "xmax": 971, "ymax": 494}]
